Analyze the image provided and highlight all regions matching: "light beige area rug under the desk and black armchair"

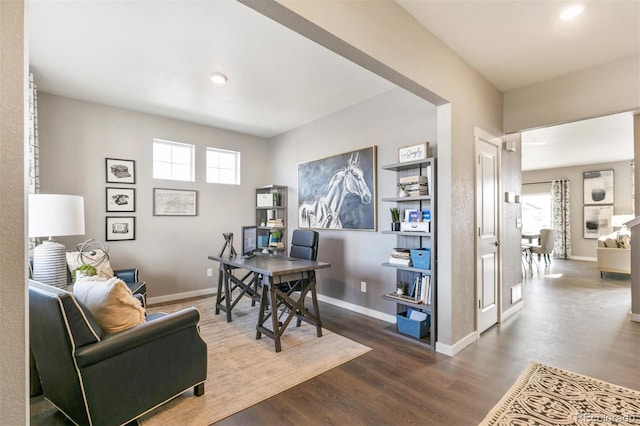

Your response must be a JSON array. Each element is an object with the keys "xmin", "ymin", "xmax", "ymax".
[{"xmin": 139, "ymin": 297, "xmax": 371, "ymax": 426}]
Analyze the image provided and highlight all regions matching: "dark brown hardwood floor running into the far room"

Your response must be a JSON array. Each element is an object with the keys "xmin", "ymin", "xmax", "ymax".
[{"xmin": 32, "ymin": 259, "xmax": 640, "ymax": 426}]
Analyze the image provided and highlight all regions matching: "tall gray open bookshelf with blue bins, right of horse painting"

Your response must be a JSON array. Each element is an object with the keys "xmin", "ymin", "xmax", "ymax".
[{"xmin": 382, "ymin": 158, "xmax": 437, "ymax": 349}]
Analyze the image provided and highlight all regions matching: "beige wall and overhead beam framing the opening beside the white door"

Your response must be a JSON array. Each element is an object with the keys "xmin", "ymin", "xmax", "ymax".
[{"xmin": 270, "ymin": 0, "xmax": 503, "ymax": 354}]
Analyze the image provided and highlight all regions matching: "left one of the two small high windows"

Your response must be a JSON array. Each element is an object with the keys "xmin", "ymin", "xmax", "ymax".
[{"xmin": 153, "ymin": 139, "xmax": 195, "ymax": 182}]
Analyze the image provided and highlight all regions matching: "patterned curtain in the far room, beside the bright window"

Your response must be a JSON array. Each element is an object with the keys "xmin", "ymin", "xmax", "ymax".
[{"xmin": 551, "ymin": 179, "xmax": 571, "ymax": 259}]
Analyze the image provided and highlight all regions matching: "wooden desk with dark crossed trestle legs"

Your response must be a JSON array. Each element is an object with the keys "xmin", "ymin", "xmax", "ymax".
[{"xmin": 209, "ymin": 254, "xmax": 331, "ymax": 352}]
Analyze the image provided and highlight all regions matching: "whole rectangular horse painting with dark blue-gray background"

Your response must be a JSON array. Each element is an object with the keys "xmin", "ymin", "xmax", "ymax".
[{"xmin": 298, "ymin": 145, "xmax": 378, "ymax": 231}]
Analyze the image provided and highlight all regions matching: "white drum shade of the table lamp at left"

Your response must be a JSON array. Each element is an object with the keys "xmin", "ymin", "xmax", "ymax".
[{"xmin": 29, "ymin": 194, "xmax": 84, "ymax": 237}]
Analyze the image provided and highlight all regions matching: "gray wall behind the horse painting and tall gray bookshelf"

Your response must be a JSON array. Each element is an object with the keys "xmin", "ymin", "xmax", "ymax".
[{"xmin": 272, "ymin": 89, "xmax": 437, "ymax": 315}]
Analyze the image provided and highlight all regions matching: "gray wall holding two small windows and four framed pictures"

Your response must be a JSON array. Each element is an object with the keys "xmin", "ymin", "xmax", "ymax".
[{"xmin": 39, "ymin": 93, "xmax": 273, "ymax": 301}]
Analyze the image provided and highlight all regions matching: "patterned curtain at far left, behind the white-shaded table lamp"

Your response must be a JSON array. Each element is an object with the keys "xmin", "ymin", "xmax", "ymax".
[{"xmin": 25, "ymin": 73, "xmax": 40, "ymax": 251}]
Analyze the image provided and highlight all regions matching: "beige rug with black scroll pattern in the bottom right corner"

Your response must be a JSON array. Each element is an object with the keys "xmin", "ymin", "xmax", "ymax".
[{"xmin": 480, "ymin": 362, "xmax": 640, "ymax": 426}]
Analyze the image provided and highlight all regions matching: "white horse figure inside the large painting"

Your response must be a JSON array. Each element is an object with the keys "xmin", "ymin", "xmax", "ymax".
[{"xmin": 298, "ymin": 153, "xmax": 371, "ymax": 229}]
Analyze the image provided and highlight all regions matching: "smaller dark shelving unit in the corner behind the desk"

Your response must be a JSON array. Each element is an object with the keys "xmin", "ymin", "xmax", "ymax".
[{"xmin": 256, "ymin": 185, "xmax": 288, "ymax": 254}]
